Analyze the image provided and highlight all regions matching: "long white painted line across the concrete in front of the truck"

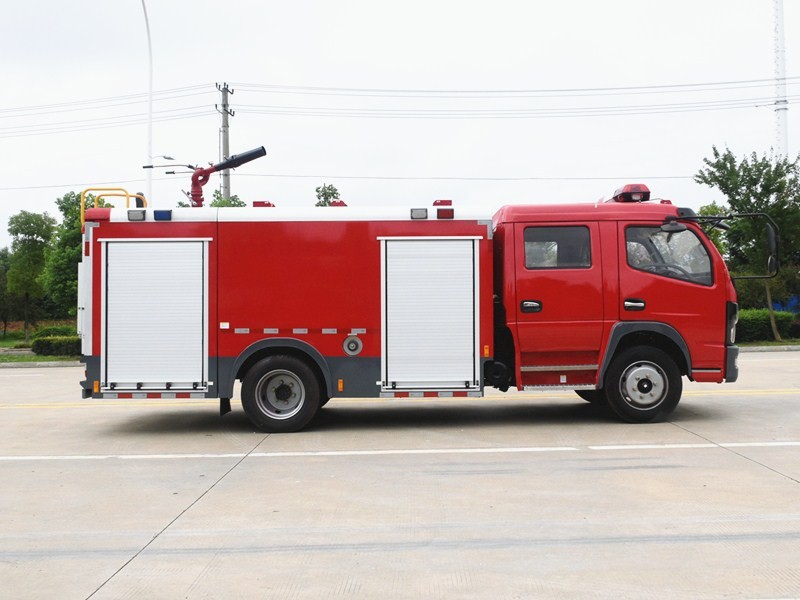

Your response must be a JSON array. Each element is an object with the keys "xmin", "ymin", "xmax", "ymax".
[{"xmin": 0, "ymin": 441, "xmax": 800, "ymax": 462}]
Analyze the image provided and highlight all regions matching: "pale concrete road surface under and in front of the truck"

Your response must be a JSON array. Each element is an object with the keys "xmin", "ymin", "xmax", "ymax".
[{"xmin": 0, "ymin": 352, "xmax": 800, "ymax": 600}]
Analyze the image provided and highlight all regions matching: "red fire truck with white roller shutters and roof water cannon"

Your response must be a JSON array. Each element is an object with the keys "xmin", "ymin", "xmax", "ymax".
[{"xmin": 78, "ymin": 148, "xmax": 776, "ymax": 432}]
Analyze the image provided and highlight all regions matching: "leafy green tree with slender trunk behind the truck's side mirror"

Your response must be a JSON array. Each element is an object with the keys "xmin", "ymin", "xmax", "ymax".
[{"xmin": 694, "ymin": 146, "xmax": 800, "ymax": 340}]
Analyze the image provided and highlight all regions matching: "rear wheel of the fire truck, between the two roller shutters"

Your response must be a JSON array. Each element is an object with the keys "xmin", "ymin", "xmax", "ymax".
[{"xmin": 242, "ymin": 354, "xmax": 321, "ymax": 433}]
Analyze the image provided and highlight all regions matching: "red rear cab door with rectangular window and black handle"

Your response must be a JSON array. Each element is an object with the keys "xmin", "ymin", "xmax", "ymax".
[{"xmin": 507, "ymin": 222, "xmax": 603, "ymax": 387}]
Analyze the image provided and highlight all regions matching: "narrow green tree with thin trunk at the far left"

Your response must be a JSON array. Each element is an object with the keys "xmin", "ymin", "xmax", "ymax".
[{"xmin": 6, "ymin": 210, "xmax": 56, "ymax": 342}]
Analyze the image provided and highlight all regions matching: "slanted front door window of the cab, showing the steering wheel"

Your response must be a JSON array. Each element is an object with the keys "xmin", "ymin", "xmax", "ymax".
[{"xmin": 625, "ymin": 227, "xmax": 714, "ymax": 285}]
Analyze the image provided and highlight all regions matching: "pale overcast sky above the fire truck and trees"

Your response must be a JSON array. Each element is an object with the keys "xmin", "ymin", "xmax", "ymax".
[{"xmin": 0, "ymin": 0, "xmax": 800, "ymax": 247}]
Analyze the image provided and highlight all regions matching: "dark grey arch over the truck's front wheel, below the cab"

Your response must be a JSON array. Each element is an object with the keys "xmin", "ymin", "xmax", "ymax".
[{"xmin": 597, "ymin": 321, "xmax": 692, "ymax": 387}]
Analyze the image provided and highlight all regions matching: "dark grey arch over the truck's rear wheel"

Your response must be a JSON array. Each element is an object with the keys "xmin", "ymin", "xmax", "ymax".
[{"xmin": 219, "ymin": 338, "xmax": 333, "ymax": 398}]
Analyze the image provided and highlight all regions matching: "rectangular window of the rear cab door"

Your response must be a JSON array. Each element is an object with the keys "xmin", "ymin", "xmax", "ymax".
[{"xmin": 524, "ymin": 226, "xmax": 592, "ymax": 269}]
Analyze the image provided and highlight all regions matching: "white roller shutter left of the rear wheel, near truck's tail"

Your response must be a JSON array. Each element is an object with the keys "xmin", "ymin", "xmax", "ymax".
[{"xmin": 104, "ymin": 241, "xmax": 207, "ymax": 389}]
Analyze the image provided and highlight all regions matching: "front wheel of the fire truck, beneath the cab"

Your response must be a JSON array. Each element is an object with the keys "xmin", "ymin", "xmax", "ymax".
[{"xmin": 605, "ymin": 346, "xmax": 683, "ymax": 423}]
